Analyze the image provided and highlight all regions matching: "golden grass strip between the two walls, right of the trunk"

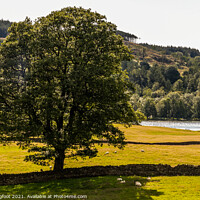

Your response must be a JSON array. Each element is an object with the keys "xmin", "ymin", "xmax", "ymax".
[{"xmin": 65, "ymin": 145, "xmax": 200, "ymax": 167}]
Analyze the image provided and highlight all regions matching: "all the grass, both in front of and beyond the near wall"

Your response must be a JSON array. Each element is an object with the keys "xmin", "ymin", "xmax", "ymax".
[{"xmin": 0, "ymin": 125, "xmax": 200, "ymax": 200}]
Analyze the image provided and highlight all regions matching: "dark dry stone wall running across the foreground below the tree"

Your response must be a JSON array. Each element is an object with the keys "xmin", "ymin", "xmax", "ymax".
[{"xmin": 0, "ymin": 164, "xmax": 200, "ymax": 185}]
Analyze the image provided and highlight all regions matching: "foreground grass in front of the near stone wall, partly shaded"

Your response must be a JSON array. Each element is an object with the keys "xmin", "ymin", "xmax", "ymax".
[{"xmin": 0, "ymin": 176, "xmax": 200, "ymax": 200}]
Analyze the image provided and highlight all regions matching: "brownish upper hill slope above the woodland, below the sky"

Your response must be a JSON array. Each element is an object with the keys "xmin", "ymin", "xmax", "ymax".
[{"xmin": 124, "ymin": 41, "xmax": 200, "ymax": 74}]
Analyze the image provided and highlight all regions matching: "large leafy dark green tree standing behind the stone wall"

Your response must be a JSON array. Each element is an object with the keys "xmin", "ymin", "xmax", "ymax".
[{"xmin": 0, "ymin": 7, "xmax": 136, "ymax": 170}]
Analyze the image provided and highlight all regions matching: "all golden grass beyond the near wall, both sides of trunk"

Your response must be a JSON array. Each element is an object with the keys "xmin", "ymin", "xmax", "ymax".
[{"xmin": 0, "ymin": 125, "xmax": 200, "ymax": 173}]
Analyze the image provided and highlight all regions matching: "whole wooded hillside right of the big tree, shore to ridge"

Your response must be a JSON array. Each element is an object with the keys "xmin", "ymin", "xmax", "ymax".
[{"xmin": 122, "ymin": 44, "xmax": 200, "ymax": 119}]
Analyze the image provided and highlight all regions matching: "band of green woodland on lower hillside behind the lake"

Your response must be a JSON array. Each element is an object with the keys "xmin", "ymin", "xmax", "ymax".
[{"xmin": 122, "ymin": 56, "xmax": 200, "ymax": 119}]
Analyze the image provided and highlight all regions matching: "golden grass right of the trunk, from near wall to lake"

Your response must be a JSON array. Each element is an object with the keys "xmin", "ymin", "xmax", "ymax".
[{"xmin": 65, "ymin": 125, "xmax": 200, "ymax": 167}]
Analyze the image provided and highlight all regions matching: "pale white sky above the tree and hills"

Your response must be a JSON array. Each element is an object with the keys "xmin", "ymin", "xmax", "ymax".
[{"xmin": 0, "ymin": 0, "xmax": 200, "ymax": 50}]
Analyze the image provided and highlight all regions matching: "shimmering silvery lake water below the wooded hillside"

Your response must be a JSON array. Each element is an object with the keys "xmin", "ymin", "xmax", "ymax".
[{"xmin": 141, "ymin": 120, "xmax": 200, "ymax": 131}]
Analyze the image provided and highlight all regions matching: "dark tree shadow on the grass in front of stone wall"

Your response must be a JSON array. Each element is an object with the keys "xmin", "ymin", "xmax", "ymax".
[{"xmin": 0, "ymin": 176, "xmax": 163, "ymax": 200}]
